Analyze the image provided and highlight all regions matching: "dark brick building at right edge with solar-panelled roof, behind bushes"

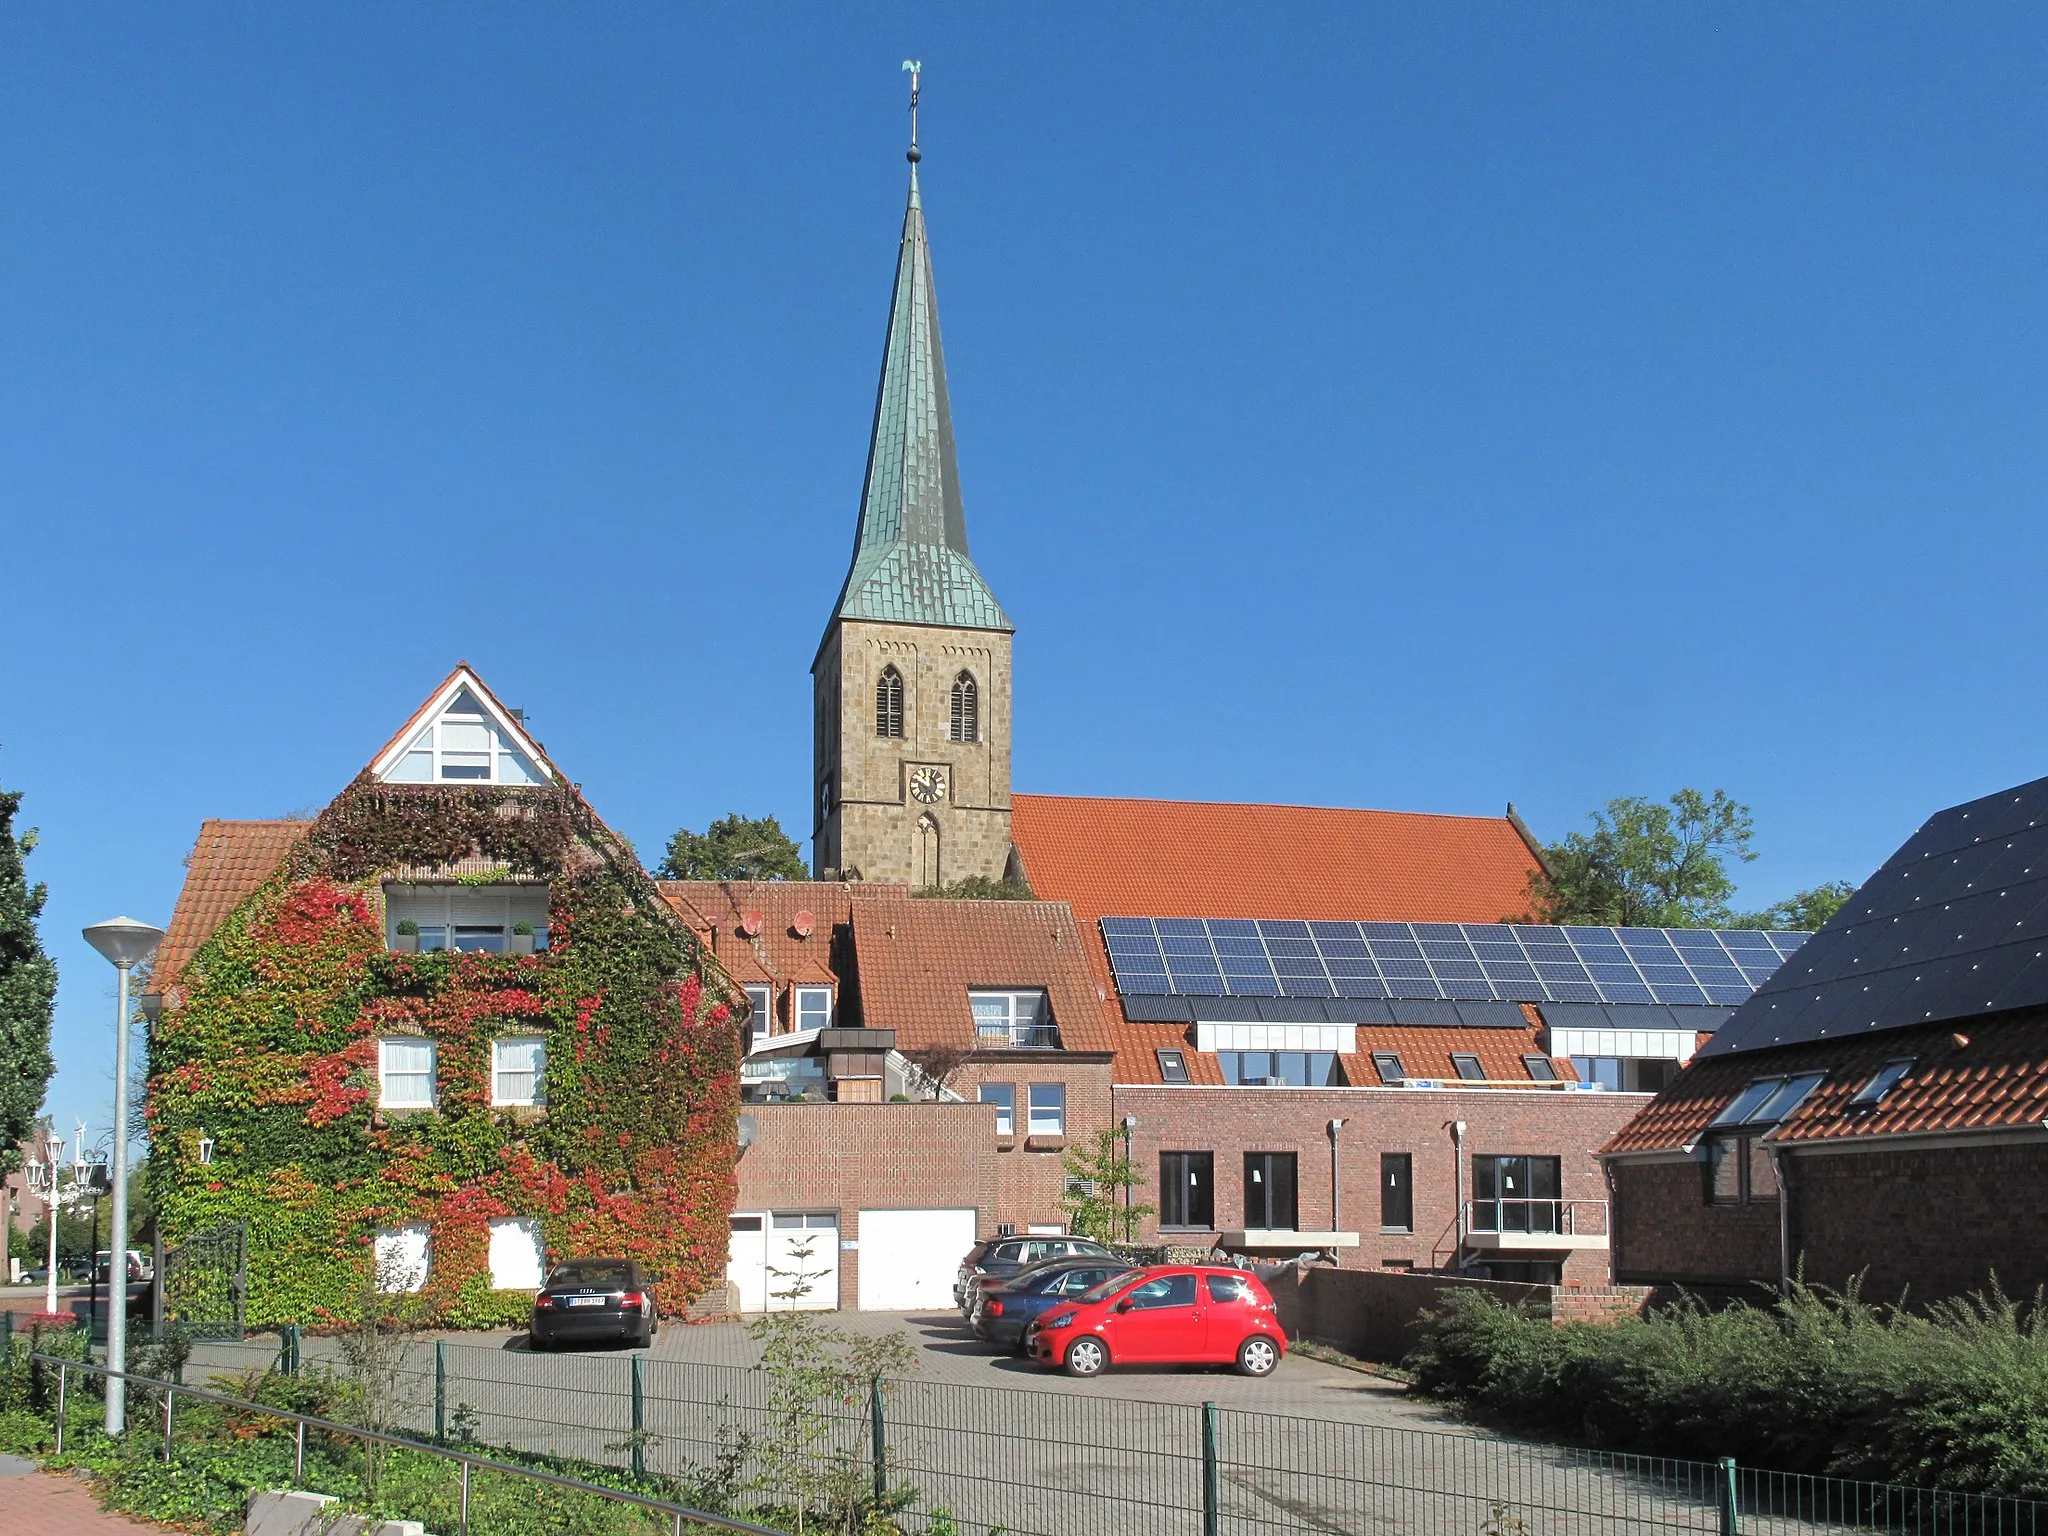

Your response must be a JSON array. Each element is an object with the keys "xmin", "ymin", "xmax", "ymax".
[{"xmin": 1606, "ymin": 780, "xmax": 2048, "ymax": 1300}]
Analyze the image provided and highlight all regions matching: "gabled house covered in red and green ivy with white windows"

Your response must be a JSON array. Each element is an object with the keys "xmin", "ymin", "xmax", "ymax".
[{"xmin": 145, "ymin": 664, "xmax": 745, "ymax": 1327}]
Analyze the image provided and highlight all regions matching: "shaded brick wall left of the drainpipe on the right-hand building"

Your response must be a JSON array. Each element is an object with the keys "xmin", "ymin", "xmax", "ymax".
[{"xmin": 1614, "ymin": 1159, "xmax": 1778, "ymax": 1288}]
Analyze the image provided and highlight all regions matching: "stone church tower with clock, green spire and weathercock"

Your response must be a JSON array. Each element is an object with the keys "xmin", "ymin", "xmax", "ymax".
[{"xmin": 811, "ymin": 74, "xmax": 1014, "ymax": 887}]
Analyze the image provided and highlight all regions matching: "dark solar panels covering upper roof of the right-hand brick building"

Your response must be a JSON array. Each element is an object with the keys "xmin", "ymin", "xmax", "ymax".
[{"xmin": 1702, "ymin": 778, "xmax": 2048, "ymax": 1055}]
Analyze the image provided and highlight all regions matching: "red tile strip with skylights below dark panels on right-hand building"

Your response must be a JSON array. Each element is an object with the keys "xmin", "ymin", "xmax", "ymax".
[{"xmin": 1606, "ymin": 1012, "xmax": 2048, "ymax": 1153}]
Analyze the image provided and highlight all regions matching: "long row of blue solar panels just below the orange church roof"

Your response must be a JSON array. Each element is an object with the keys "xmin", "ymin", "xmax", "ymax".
[{"xmin": 1102, "ymin": 918, "xmax": 1808, "ymax": 1008}]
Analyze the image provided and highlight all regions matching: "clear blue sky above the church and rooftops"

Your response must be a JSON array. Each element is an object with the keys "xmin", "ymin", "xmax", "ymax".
[{"xmin": 12, "ymin": 4, "xmax": 2048, "ymax": 1126}]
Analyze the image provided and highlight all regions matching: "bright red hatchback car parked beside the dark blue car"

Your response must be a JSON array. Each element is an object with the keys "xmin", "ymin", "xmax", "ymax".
[{"xmin": 1024, "ymin": 1264, "xmax": 1286, "ymax": 1376}]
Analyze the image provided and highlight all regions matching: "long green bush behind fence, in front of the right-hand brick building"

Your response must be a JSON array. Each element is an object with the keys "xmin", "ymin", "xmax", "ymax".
[{"xmin": 1405, "ymin": 1286, "xmax": 2048, "ymax": 1497}]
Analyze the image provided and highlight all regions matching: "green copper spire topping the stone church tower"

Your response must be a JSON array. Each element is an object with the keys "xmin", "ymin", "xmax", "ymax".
[{"xmin": 838, "ymin": 144, "xmax": 1014, "ymax": 631}]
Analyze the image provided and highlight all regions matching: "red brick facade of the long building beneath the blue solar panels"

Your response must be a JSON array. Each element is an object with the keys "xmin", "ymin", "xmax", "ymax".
[{"xmin": 1112, "ymin": 1087, "xmax": 1647, "ymax": 1284}]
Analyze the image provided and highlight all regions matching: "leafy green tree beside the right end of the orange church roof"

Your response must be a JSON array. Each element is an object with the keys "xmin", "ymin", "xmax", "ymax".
[{"xmin": 1530, "ymin": 788, "xmax": 1755, "ymax": 928}]
